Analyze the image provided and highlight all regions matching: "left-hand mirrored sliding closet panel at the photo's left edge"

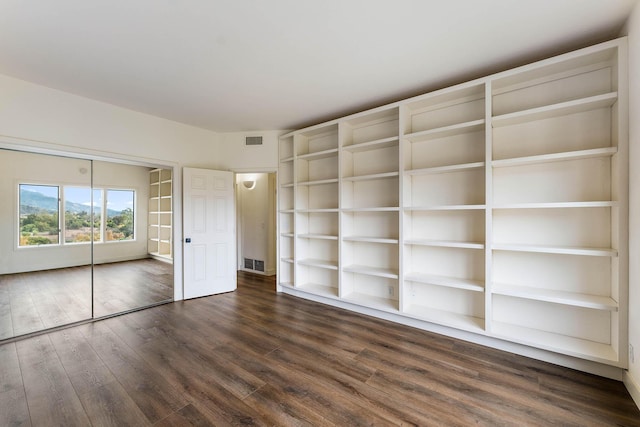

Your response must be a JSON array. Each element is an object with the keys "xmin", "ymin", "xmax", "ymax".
[{"xmin": 0, "ymin": 150, "xmax": 92, "ymax": 340}]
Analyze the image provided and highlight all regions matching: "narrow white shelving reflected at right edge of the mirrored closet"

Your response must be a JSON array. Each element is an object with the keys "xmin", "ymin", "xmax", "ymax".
[{"xmin": 147, "ymin": 169, "xmax": 173, "ymax": 260}]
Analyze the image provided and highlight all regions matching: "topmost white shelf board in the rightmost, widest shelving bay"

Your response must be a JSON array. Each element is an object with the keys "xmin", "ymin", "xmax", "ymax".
[{"xmin": 492, "ymin": 92, "xmax": 618, "ymax": 127}]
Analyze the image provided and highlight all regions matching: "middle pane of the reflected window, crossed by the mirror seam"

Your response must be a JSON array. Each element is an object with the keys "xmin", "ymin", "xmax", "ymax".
[{"xmin": 64, "ymin": 187, "xmax": 102, "ymax": 243}]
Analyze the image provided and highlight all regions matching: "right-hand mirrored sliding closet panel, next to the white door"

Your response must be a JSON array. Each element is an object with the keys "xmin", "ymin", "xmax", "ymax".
[{"xmin": 93, "ymin": 161, "xmax": 173, "ymax": 317}]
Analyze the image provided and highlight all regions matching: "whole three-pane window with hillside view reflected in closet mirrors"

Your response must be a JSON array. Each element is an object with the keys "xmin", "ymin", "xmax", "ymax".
[{"xmin": 18, "ymin": 184, "xmax": 135, "ymax": 247}]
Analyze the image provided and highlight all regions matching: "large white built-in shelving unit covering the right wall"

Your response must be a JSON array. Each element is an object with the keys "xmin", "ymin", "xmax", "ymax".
[{"xmin": 279, "ymin": 38, "xmax": 628, "ymax": 367}]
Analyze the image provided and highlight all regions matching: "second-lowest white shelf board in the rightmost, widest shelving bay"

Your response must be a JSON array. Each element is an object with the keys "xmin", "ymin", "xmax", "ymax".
[{"xmin": 491, "ymin": 283, "xmax": 618, "ymax": 311}]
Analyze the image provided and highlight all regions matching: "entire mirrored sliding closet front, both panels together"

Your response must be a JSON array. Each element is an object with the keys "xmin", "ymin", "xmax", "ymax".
[{"xmin": 0, "ymin": 149, "xmax": 173, "ymax": 341}]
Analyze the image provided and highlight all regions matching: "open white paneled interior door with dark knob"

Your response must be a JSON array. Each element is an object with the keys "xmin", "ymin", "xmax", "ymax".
[{"xmin": 183, "ymin": 168, "xmax": 237, "ymax": 299}]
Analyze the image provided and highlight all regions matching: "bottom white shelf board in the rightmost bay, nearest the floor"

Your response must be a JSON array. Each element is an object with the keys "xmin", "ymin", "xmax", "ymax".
[{"xmin": 491, "ymin": 321, "xmax": 618, "ymax": 363}]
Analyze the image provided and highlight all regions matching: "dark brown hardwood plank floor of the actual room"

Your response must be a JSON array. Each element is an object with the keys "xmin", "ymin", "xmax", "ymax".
[{"xmin": 0, "ymin": 273, "xmax": 640, "ymax": 426}]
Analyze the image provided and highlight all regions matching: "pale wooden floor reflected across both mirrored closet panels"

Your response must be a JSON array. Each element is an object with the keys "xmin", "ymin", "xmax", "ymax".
[{"xmin": 0, "ymin": 259, "xmax": 173, "ymax": 339}]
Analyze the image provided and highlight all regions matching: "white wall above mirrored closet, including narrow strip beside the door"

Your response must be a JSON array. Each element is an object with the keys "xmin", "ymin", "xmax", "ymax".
[{"xmin": 0, "ymin": 75, "xmax": 220, "ymax": 299}]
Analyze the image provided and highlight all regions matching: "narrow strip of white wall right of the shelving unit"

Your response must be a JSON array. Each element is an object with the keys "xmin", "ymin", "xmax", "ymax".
[{"xmin": 624, "ymin": 4, "xmax": 640, "ymax": 406}]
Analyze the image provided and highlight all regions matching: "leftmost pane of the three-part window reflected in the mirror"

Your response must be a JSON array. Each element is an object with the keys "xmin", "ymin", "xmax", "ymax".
[{"xmin": 19, "ymin": 184, "xmax": 60, "ymax": 246}]
